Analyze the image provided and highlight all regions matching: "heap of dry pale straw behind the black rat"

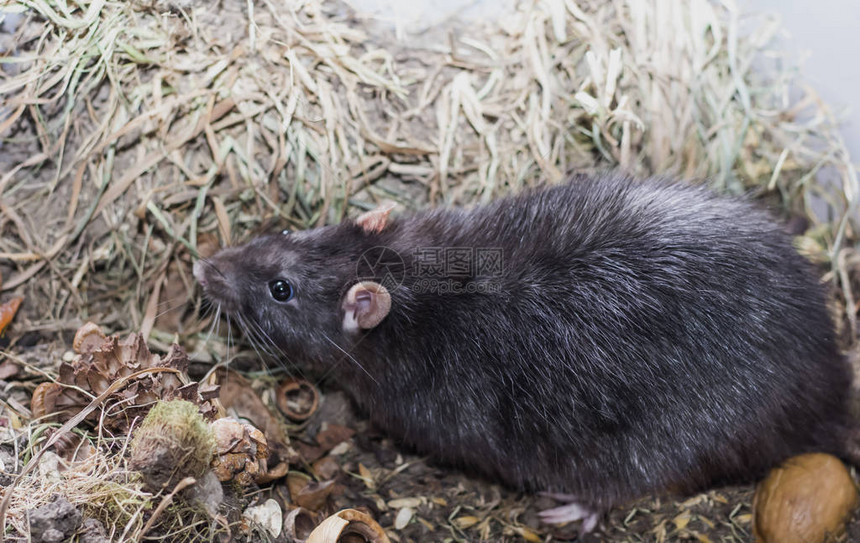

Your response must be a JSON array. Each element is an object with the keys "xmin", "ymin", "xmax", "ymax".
[{"xmin": 0, "ymin": 0, "xmax": 860, "ymax": 540}]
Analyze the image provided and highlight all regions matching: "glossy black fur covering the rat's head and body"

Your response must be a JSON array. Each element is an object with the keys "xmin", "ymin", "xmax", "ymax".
[{"xmin": 201, "ymin": 177, "xmax": 851, "ymax": 509}]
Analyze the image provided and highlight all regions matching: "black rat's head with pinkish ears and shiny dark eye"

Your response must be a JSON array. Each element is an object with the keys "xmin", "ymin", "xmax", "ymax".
[{"xmin": 194, "ymin": 207, "xmax": 391, "ymax": 358}]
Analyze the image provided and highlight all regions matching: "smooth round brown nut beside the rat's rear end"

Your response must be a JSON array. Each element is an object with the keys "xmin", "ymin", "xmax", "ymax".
[{"xmin": 753, "ymin": 453, "xmax": 857, "ymax": 543}]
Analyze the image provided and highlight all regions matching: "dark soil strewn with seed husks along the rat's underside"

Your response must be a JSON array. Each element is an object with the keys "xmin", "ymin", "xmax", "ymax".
[{"xmin": 276, "ymin": 380, "xmax": 860, "ymax": 543}]
